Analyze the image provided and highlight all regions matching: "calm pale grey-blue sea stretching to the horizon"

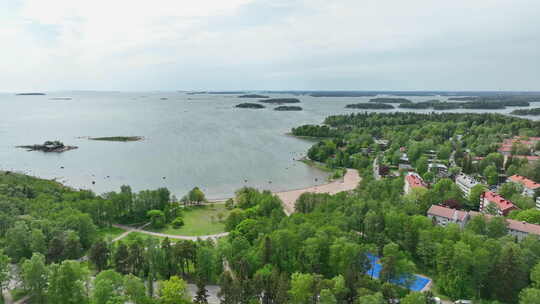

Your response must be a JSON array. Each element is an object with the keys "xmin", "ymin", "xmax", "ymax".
[{"xmin": 0, "ymin": 92, "xmax": 540, "ymax": 198}]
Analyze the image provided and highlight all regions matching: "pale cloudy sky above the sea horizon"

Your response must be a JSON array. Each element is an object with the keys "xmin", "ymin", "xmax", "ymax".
[{"xmin": 0, "ymin": 0, "xmax": 540, "ymax": 92}]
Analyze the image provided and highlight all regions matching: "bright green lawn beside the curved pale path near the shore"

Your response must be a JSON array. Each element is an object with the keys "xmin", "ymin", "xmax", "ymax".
[{"xmin": 152, "ymin": 204, "xmax": 230, "ymax": 236}]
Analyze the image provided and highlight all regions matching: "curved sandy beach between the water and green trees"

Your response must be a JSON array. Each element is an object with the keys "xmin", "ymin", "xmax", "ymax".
[{"xmin": 275, "ymin": 169, "xmax": 360, "ymax": 215}]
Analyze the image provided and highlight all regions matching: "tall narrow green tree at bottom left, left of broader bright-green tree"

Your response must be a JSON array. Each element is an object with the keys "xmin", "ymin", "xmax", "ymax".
[{"xmin": 21, "ymin": 253, "xmax": 49, "ymax": 304}]
